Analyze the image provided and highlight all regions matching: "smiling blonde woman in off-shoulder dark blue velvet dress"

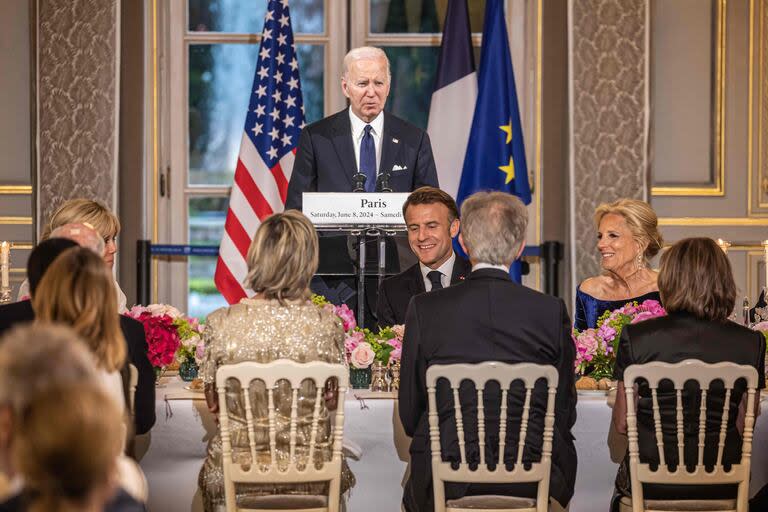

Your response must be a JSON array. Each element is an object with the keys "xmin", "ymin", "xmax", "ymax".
[{"xmin": 574, "ymin": 199, "xmax": 663, "ymax": 331}]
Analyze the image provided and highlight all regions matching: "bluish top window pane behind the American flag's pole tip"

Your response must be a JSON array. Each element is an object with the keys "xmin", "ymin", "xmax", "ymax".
[{"xmin": 188, "ymin": 0, "xmax": 323, "ymax": 34}]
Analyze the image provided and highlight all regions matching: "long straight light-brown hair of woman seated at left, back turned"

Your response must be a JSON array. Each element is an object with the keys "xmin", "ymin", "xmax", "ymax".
[{"xmin": 32, "ymin": 247, "xmax": 126, "ymax": 372}]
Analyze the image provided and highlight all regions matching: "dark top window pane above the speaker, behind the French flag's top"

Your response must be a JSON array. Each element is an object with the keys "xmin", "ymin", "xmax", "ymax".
[{"xmin": 370, "ymin": 0, "xmax": 485, "ymax": 34}]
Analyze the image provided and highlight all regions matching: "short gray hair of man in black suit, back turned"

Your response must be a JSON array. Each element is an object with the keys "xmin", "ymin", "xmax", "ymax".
[{"xmin": 461, "ymin": 192, "xmax": 528, "ymax": 265}]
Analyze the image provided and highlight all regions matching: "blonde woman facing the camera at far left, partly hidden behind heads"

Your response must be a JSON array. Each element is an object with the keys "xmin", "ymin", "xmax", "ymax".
[{"xmin": 19, "ymin": 199, "xmax": 127, "ymax": 313}]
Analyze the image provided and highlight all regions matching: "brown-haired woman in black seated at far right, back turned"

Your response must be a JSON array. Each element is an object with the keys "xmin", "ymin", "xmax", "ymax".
[{"xmin": 612, "ymin": 238, "xmax": 765, "ymax": 510}]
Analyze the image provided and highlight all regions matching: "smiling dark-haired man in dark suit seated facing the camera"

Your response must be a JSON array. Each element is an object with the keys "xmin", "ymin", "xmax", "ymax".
[{"xmin": 376, "ymin": 187, "xmax": 471, "ymax": 327}]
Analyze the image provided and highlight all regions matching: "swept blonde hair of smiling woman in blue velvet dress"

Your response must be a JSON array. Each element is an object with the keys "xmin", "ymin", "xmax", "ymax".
[{"xmin": 594, "ymin": 198, "xmax": 664, "ymax": 262}]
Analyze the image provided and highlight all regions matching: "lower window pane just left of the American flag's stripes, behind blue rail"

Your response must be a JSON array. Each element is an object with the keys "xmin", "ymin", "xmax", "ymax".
[{"xmin": 187, "ymin": 197, "xmax": 229, "ymax": 320}]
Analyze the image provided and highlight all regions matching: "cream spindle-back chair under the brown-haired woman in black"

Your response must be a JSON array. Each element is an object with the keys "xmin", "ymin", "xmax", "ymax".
[{"xmin": 620, "ymin": 359, "xmax": 758, "ymax": 512}]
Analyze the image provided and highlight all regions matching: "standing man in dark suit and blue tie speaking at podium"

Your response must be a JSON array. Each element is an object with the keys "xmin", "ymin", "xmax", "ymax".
[{"xmin": 285, "ymin": 47, "xmax": 438, "ymax": 210}]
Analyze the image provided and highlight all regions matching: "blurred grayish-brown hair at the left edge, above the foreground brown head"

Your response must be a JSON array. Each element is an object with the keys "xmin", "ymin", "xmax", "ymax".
[{"xmin": 0, "ymin": 323, "xmax": 97, "ymax": 414}]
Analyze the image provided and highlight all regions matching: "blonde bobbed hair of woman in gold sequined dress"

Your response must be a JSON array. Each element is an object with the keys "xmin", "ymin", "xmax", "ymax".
[{"xmin": 245, "ymin": 210, "xmax": 319, "ymax": 305}]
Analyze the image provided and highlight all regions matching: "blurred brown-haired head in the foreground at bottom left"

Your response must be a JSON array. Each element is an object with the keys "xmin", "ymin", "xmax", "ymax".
[{"xmin": 11, "ymin": 381, "xmax": 123, "ymax": 512}]
